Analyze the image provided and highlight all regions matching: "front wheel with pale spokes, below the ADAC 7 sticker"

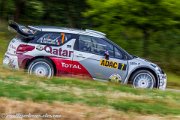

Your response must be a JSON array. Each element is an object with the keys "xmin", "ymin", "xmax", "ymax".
[{"xmin": 131, "ymin": 70, "xmax": 156, "ymax": 89}]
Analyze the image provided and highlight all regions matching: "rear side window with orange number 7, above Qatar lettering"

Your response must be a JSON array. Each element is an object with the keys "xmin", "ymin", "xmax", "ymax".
[{"xmin": 36, "ymin": 33, "xmax": 72, "ymax": 46}]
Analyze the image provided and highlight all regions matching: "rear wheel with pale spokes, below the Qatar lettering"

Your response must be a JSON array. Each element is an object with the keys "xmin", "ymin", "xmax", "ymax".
[{"xmin": 28, "ymin": 58, "xmax": 54, "ymax": 78}]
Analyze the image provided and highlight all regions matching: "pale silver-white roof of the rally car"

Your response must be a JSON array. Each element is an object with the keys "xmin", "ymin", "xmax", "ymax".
[{"xmin": 32, "ymin": 26, "xmax": 105, "ymax": 38}]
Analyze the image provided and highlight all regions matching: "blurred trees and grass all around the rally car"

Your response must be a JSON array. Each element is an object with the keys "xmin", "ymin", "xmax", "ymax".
[{"xmin": 0, "ymin": 0, "xmax": 180, "ymax": 120}]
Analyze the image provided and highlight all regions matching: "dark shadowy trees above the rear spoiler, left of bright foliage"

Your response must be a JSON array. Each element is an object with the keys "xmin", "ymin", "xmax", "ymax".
[{"xmin": 0, "ymin": 0, "xmax": 87, "ymax": 28}]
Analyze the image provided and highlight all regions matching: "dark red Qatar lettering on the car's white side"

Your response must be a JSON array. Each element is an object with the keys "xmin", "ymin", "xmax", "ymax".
[{"xmin": 43, "ymin": 46, "xmax": 73, "ymax": 57}]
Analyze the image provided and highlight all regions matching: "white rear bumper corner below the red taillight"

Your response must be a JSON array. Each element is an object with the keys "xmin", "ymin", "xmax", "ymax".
[{"xmin": 3, "ymin": 53, "xmax": 19, "ymax": 69}]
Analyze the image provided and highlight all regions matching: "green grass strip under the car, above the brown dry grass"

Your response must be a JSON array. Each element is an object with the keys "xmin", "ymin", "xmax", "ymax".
[{"xmin": 0, "ymin": 21, "xmax": 180, "ymax": 115}]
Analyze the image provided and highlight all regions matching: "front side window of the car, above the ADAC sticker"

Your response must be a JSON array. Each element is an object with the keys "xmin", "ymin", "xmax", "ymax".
[{"xmin": 79, "ymin": 35, "xmax": 114, "ymax": 57}]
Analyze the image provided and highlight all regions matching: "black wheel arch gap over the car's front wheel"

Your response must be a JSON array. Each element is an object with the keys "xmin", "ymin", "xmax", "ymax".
[{"xmin": 128, "ymin": 67, "xmax": 158, "ymax": 88}]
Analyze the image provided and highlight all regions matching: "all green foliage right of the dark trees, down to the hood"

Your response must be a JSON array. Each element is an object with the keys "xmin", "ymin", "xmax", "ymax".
[{"xmin": 84, "ymin": 0, "xmax": 180, "ymax": 73}]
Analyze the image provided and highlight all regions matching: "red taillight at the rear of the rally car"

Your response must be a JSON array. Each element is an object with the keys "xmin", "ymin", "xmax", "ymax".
[{"xmin": 16, "ymin": 44, "xmax": 35, "ymax": 54}]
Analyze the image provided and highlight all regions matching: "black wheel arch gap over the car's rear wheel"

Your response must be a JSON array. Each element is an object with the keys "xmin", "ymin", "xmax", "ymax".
[{"xmin": 25, "ymin": 56, "xmax": 57, "ymax": 75}]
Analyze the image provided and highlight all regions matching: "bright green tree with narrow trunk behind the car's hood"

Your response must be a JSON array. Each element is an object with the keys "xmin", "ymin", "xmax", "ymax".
[{"xmin": 85, "ymin": 0, "xmax": 180, "ymax": 57}]
